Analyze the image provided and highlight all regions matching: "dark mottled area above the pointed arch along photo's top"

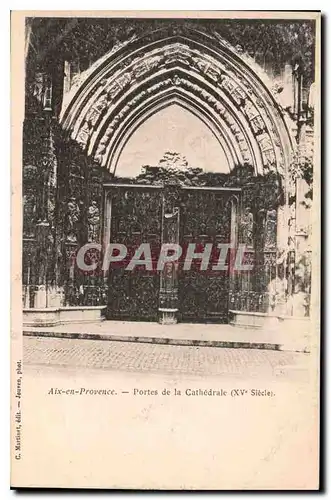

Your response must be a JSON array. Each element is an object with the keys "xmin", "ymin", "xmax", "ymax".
[{"xmin": 28, "ymin": 18, "xmax": 315, "ymax": 84}]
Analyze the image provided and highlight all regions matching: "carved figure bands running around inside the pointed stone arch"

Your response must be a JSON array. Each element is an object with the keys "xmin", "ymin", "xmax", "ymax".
[{"xmin": 68, "ymin": 42, "xmax": 290, "ymax": 178}]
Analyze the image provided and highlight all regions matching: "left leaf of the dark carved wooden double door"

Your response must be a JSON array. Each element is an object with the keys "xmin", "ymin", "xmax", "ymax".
[{"xmin": 107, "ymin": 186, "xmax": 162, "ymax": 321}]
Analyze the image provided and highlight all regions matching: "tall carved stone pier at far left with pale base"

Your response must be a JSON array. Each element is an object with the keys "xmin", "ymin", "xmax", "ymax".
[{"xmin": 23, "ymin": 58, "xmax": 66, "ymax": 308}]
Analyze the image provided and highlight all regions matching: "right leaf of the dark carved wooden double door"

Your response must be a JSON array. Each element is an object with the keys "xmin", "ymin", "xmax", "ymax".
[{"xmin": 179, "ymin": 189, "xmax": 231, "ymax": 322}]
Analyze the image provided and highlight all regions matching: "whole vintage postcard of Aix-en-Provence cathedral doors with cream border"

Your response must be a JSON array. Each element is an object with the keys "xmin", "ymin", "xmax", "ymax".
[{"xmin": 11, "ymin": 11, "xmax": 321, "ymax": 490}]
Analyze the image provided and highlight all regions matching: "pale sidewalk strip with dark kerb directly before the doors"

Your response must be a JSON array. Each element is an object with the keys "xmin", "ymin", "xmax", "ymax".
[{"xmin": 23, "ymin": 321, "xmax": 309, "ymax": 352}]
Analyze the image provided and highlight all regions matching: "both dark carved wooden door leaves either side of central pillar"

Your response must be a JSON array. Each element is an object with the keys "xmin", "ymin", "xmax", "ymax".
[{"xmin": 108, "ymin": 187, "xmax": 237, "ymax": 322}]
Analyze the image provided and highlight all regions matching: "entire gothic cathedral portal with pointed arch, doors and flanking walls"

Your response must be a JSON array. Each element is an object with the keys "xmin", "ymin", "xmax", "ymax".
[{"xmin": 22, "ymin": 18, "xmax": 314, "ymax": 324}]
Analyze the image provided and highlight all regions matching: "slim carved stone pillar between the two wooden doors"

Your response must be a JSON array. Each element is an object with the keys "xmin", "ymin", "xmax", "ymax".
[{"xmin": 159, "ymin": 185, "xmax": 180, "ymax": 325}]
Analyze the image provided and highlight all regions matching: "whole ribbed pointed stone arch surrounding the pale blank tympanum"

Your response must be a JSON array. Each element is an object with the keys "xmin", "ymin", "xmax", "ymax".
[{"xmin": 62, "ymin": 32, "xmax": 291, "ymax": 178}]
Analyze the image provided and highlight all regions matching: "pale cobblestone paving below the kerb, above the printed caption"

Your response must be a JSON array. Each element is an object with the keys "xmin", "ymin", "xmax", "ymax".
[{"xmin": 23, "ymin": 337, "xmax": 309, "ymax": 380}]
